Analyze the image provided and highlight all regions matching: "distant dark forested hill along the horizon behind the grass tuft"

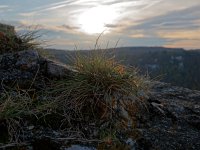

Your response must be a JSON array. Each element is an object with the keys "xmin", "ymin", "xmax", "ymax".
[{"xmin": 41, "ymin": 47, "xmax": 200, "ymax": 90}]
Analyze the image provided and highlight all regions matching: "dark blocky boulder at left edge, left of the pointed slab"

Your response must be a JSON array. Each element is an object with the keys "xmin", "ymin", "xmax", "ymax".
[{"xmin": 0, "ymin": 50, "xmax": 40, "ymax": 82}]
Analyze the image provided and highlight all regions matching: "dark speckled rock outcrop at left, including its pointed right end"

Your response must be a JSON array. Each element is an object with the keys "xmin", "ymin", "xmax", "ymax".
[{"xmin": 0, "ymin": 50, "xmax": 76, "ymax": 89}]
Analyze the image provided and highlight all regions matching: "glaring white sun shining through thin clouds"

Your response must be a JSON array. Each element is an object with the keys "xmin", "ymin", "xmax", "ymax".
[{"xmin": 78, "ymin": 6, "xmax": 118, "ymax": 34}]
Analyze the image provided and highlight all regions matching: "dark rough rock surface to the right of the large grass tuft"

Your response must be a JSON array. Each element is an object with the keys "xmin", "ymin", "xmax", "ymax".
[{"xmin": 138, "ymin": 82, "xmax": 200, "ymax": 150}]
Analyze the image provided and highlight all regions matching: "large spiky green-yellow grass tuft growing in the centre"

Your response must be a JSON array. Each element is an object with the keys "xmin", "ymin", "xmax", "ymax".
[{"xmin": 50, "ymin": 50, "xmax": 148, "ymax": 120}]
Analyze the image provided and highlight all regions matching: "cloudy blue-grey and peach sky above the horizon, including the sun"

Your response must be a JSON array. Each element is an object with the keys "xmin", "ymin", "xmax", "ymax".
[{"xmin": 0, "ymin": 0, "xmax": 200, "ymax": 50}]
